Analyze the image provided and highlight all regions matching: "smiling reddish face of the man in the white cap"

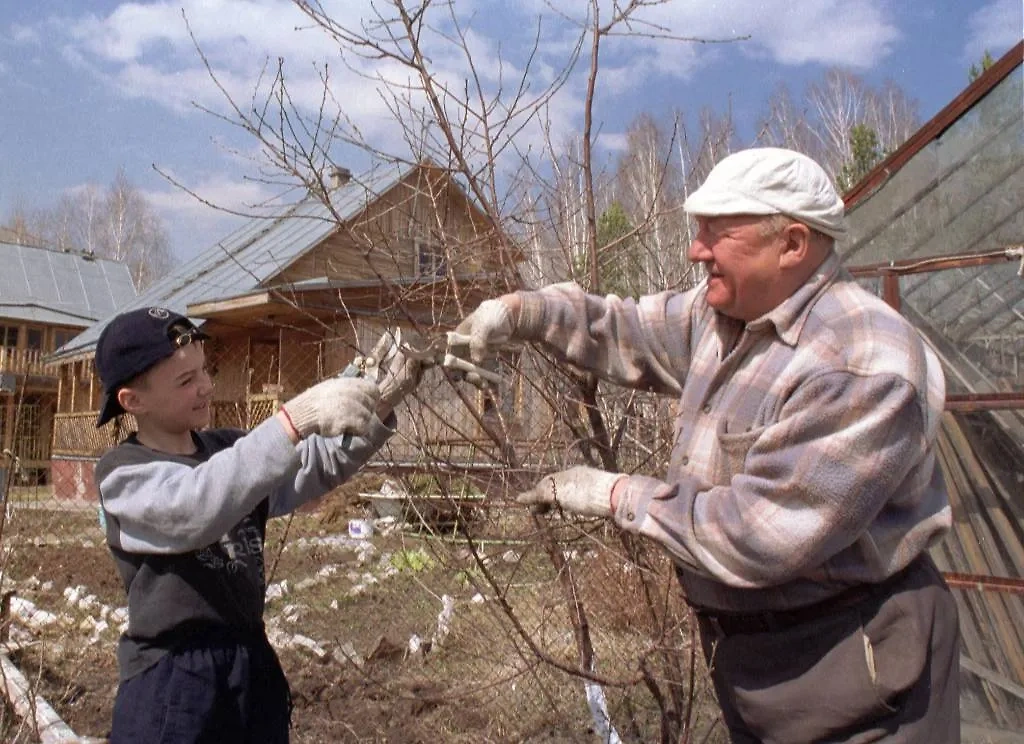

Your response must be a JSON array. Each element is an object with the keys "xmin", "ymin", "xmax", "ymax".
[{"xmin": 688, "ymin": 215, "xmax": 785, "ymax": 321}]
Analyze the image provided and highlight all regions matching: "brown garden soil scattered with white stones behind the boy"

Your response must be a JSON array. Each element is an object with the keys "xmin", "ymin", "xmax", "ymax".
[{"xmin": 0, "ymin": 485, "xmax": 721, "ymax": 744}]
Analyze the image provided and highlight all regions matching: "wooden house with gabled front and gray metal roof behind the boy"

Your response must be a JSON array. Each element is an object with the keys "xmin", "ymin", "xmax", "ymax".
[{"xmin": 53, "ymin": 163, "xmax": 517, "ymax": 497}]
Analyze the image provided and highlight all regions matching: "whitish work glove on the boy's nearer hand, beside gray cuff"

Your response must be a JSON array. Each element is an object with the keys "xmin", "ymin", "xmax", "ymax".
[{"xmin": 281, "ymin": 378, "xmax": 380, "ymax": 437}]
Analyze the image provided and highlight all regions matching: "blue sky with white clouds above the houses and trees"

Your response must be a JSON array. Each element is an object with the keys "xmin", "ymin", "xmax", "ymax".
[{"xmin": 0, "ymin": 0, "xmax": 1024, "ymax": 260}]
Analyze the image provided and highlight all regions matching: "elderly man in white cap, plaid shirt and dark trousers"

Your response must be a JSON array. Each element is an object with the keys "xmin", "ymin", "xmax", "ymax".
[{"xmin": 456, "ymin": 148, "xmax": 959, "ymax": 744}]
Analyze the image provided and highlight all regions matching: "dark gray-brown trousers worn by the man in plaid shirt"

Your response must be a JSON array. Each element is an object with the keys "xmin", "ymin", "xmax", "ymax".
[{"xmin": 697, "ymin": 556, "xmax": 961, "ymax": 744}]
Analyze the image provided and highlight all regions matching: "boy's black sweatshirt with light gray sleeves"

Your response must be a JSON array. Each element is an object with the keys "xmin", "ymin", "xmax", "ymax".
[{"xmin": 96, "ymin": 414, "xmax": 394, "ymax": 680}]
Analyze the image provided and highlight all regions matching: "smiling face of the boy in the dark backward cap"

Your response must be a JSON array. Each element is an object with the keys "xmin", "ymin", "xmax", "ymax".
[{"xmin": 118, "ymin": 342, "xmax": 213, "ymax": 434}]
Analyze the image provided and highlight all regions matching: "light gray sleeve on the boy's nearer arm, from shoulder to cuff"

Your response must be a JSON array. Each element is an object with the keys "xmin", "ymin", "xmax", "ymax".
[{"xmin": 96, "ymin": 419, "xmax": 301, "ymax": 554}]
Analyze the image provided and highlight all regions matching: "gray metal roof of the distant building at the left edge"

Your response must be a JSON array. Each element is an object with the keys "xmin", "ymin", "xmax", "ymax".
[{"xmin": 0, "ymin": 243, "xmax": 135, "ymax": 327}]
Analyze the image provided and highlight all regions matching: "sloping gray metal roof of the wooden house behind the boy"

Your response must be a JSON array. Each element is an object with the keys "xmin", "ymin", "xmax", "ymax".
[{"xmin": 53, "ymin": 165, "xmax": 418, "ymax": 360}]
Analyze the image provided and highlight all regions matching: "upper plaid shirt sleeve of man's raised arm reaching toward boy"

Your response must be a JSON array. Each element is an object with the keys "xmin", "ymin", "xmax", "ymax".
[{"xmin": 515, "ymin": 282, "xmax": 695, "ymax": 395}]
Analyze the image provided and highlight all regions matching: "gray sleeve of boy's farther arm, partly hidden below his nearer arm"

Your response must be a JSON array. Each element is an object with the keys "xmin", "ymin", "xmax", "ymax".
[{"xmin": 270, "ymin": 408, "xmax": 396, "ymax": 517}]
